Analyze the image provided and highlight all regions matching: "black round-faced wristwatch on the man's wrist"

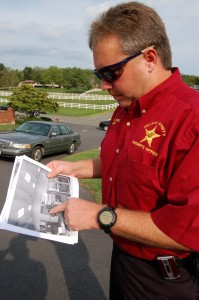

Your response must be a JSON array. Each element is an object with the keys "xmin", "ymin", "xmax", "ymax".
[{"xmin": 97, "ymin": 206, "xmax": 117, "ymax": 234}]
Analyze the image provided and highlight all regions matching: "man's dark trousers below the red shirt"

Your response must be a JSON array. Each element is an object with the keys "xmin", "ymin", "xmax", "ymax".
[{"xmin": 109, "ymin": 245, "xmax": 199, "ymax": 300}]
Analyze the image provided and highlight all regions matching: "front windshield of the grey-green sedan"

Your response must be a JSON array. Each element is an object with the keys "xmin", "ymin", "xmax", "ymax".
[{"xmin": 15, "ymin": 122, "xmax": 50, "ymax": 136}]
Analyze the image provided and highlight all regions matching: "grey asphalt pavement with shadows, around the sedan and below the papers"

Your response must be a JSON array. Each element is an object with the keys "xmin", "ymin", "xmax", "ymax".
[{"xmin": 0, "ymin": 118, "xmax": 112, "ymax": 300}]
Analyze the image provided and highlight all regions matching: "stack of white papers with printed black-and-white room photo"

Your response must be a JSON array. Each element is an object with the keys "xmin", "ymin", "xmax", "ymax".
[{"xmin": 0, "ymin": 155, "xmax": 79, "ymax": 244}]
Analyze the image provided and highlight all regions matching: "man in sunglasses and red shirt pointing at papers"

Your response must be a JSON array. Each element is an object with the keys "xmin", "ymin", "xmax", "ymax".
[{"xmin": 49, "ymin": 2, "xmax": 199, "ymax": 300}]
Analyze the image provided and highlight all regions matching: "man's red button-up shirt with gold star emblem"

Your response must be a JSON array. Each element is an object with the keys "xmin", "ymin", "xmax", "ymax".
[{"xmin": 101, "ymin": 69, "xmax": 199, "ymax": 259}]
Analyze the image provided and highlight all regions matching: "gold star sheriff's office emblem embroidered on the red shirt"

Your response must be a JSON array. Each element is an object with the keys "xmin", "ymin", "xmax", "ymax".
[{"xmin": 132, "ymin": 121, "xmax": 166, "ymax": 156}]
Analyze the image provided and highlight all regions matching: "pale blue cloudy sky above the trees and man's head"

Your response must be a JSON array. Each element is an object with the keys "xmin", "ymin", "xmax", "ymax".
[{"xmin": 0, "ymin": 0, "xmax": 199, "ymax": 76}]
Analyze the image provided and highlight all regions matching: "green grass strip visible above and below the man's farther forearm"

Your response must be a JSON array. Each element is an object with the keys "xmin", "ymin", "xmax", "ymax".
[{"xmin": 62, "ymin": 149, "xmax": 102, "ymax": 203}]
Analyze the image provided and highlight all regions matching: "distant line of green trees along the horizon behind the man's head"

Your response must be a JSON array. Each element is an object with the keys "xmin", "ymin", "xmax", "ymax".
[{"xmin": 0, "ymin": 63, "xmax": 199, "ymax": 91}]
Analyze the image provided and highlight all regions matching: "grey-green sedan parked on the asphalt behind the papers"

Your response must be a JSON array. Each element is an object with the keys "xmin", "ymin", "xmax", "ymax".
[{"xmin": 0, "ymin": 121, "xmax": 81, "ymax": 161}]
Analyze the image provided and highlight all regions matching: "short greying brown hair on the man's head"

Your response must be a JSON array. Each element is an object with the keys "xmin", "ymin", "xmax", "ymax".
[{"xmin": 89, "ymin": 2, "xmax": 172, "ymax": 70}]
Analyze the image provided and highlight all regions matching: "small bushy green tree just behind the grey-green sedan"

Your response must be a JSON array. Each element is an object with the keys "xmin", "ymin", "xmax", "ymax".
[{"xmin": 9, "ymin": 84, "xmax": 59, "ymax": 115}]
